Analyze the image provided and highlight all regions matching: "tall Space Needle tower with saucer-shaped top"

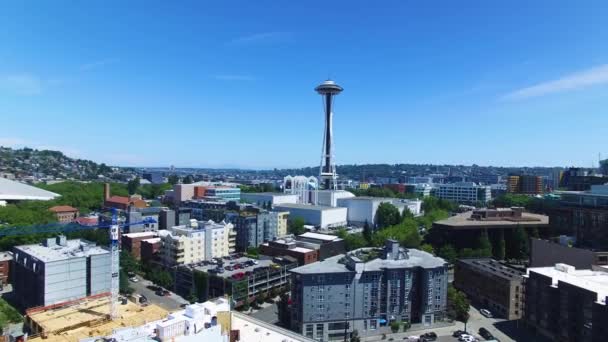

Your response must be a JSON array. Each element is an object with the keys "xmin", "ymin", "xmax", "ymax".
[{"xmin": 315, "ymin": 80, "xmax": 343, "ymax": 190}]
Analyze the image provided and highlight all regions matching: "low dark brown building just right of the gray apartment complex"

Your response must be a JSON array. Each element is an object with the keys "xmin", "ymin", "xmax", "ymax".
[{"xmin": 454, "ymin": 258, "xmax": 525, "ymax": 320}]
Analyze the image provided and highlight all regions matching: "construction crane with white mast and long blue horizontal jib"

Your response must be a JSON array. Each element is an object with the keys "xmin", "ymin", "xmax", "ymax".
[{"xmin": 0, "ymin": 208, "xmax": 156, "ymax": 319}]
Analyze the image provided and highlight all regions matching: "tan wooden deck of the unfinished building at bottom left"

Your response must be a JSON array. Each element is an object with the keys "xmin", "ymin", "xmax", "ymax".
[{"xmin": 25, "ymin": 295, "xmax": 168, "ymax": 342}]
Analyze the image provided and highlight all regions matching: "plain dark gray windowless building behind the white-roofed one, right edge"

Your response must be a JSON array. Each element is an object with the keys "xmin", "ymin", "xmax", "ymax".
[{"xmin": 530, "ymin": 238, "xmax": 608, "ymax": 269}]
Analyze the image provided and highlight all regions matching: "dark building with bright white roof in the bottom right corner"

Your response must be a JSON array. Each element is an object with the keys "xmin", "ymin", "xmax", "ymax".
[{"xmin": 524, "ymin": 264, "xmax": 608, "ymax": 342}]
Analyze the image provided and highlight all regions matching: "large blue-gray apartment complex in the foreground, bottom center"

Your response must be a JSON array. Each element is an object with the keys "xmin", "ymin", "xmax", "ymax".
[{"xmin": 291, "ymin": 240, "xmax": 448, "ymax": 341}]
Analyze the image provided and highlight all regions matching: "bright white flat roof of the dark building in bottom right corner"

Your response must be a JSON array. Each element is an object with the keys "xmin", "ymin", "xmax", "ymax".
[{"xmin": 527, "ymin": 264, "xmax": 608, "ymax": 305}]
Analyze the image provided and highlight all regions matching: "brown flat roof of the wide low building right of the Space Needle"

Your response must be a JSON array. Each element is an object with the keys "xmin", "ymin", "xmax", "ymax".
[{"xmin": 433, "ymin": 211, "xmax": 549, "ymax": 229}]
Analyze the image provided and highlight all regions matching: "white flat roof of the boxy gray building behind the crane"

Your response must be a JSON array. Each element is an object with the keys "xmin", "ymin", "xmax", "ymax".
[{"xmin": 15, "ymin": 239, "xmax": 110, "ymax": 262}]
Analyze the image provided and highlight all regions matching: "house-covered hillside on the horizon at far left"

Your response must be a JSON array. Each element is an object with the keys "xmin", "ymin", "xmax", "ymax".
[{"xmin": 0, "ymin": 146, "xmax": 114, "ymax": 180}]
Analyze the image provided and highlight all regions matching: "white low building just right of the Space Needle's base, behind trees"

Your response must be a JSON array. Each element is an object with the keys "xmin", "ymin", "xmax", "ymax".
[{"xmin": 338, "ymin": 197, "xmax": 422, "ymax": 226}]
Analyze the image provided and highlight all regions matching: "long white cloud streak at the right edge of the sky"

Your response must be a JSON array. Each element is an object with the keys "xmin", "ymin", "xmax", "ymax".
[{"xmin": 503, "ymin": 64, "xmax": 608, "ymax": 100}]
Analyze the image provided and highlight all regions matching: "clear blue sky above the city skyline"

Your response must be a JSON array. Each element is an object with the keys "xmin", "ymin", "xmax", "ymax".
[{"xmin": 0, "ymin": 1, "xmax": 608, "ymax": 168}]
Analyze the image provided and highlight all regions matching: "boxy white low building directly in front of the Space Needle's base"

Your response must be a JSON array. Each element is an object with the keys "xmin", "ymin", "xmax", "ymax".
[{"xmin": 274, "ymin": 204, "xmax": 348, "ymax": 229}]
